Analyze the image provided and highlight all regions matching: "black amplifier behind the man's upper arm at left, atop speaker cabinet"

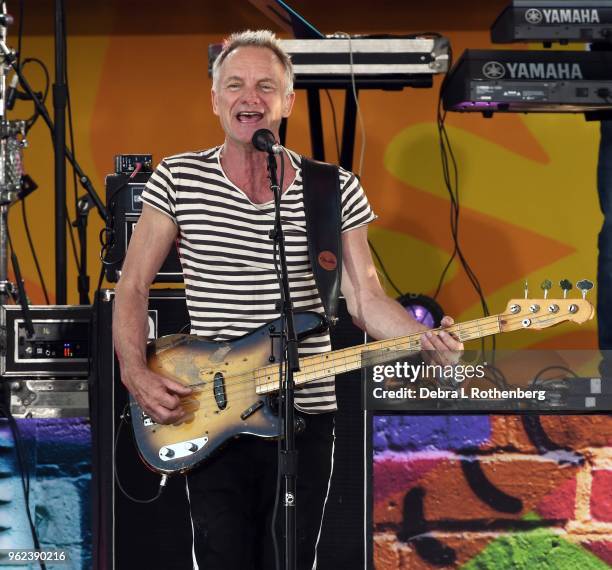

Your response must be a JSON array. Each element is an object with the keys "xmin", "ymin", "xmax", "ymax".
[{"xmin": 105, "ymin": 172, "xmax": 183, "ymax": 283}]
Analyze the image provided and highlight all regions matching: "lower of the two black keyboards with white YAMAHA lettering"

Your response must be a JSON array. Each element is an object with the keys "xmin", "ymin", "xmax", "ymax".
[{"xmin": 442, "ymin": 50, "xmax": 612, "ymax": 115}]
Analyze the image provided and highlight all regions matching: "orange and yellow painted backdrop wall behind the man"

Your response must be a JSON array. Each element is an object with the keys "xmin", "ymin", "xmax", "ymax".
[{"xmin": 4, "ymin": 1, "xmax": 601, "ymax": 348}]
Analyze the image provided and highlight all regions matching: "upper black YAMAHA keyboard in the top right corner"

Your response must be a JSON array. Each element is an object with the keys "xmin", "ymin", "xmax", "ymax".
[{"xmin": 491, "ymin": 0, "xmax": 612, "ymax": 43}]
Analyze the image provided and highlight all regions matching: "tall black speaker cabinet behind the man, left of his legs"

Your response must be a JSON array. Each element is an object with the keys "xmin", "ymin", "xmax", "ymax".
[{"xmin": 91, "ymin": 289, "xmax": 192, "ymax": 570}]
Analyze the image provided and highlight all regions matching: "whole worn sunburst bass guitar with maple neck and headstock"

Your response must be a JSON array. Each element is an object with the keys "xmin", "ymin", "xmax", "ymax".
[{"xmin": 130, "ymin": 298, "xmax": 594, "ymax": 474}]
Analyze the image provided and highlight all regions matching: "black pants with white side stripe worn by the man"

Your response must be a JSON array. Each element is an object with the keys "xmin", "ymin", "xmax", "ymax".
[{"xmin": 187, "ymin": 413, "xmax": 334, "ymax": 570}]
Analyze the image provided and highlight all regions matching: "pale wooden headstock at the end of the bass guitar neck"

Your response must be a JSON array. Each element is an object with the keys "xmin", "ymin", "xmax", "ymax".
[{"xmin": 499, "ymin": 298, "xmax": 595, "ymax": 332}]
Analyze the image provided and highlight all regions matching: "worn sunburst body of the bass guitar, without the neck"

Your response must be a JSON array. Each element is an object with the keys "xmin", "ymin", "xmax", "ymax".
[{"xmin": 130, "ymin": 313, "xmax": 325, "ymax": 473}]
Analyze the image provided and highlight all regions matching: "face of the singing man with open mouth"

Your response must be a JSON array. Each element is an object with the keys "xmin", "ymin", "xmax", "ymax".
[{"xmin": 212, "ymin": 46, "xmax": 295, "ymax": 144}]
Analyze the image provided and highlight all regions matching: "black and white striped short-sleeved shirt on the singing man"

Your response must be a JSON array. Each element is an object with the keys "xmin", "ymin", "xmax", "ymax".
[{"xmin": 142, "ymin": 147, "xmax": 376, "ymax": 413}]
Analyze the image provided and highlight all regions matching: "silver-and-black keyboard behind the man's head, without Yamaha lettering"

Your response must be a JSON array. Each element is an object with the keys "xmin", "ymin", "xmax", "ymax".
[{"xmin": 208, "ymin": 36, "xmax": 449, "ymax": 88}]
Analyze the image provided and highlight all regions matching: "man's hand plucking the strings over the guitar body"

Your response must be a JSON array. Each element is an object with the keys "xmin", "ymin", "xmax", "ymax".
[{"xmin": 121, "ymin": 368, "xmax": 193, "ymax": 424}]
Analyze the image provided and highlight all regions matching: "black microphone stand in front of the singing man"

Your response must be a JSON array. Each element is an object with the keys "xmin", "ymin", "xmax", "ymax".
[{"xmin": 267, "ymin": 151, "xmax": 300, "ymax": 570}]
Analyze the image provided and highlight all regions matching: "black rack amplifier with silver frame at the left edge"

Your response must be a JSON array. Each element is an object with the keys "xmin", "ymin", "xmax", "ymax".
[{"xmin": 0, "ymin": 305, "xmax": 91, "ymax": 378}]
